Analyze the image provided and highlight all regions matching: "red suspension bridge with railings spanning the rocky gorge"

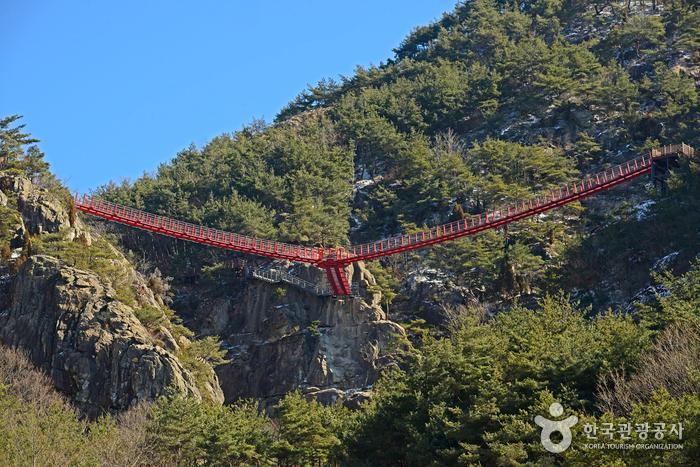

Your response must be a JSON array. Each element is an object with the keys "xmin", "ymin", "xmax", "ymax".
[{"xmin": 75, "ymin": 144, "xmax": 695, "ymax": 295}]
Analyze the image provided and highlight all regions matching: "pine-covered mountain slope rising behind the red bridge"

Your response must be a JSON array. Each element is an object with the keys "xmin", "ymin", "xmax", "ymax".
[{"xmin": 105, "ymin": 0, "xmax": 700, "ymax": 318}]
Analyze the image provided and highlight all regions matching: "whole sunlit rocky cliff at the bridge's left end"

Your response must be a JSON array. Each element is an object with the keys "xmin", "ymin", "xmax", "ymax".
[{"xmin": 0, "ymin": 173, "xmax": 223, "ymax": 416}]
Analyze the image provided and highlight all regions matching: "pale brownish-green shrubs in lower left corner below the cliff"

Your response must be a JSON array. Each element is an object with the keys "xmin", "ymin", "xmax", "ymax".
[{"xmin": 0, "ymin": 347, "xmax": 157, "ymax": 466}]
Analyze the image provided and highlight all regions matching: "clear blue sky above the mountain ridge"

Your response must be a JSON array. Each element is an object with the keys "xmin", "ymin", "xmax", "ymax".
[{"xmin": 0, "ymin": 0, "xmax": 456, "ymax": 192}]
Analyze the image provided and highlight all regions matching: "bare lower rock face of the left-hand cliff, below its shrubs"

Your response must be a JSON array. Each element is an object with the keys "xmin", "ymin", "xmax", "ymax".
[{"xmin": 0, "ymin": 256, "xmax": 221, "ymax": 416}]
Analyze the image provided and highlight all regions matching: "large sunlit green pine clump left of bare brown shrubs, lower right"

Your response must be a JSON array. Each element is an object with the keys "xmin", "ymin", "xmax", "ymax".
[{"xmin": 350, "ymin": 297, "xmax": 645, "ymax": 465}]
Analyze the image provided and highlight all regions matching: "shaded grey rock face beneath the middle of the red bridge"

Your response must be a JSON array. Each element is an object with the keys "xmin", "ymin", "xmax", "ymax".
[{"xmin": 209, "ymin": 267, "xmax": 405, "ymax": 401}]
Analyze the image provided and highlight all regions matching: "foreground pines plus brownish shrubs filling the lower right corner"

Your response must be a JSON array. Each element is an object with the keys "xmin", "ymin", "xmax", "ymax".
[{"xmin": 346, "ymin": 267, "xmax": 700, "ymax": 465}]
